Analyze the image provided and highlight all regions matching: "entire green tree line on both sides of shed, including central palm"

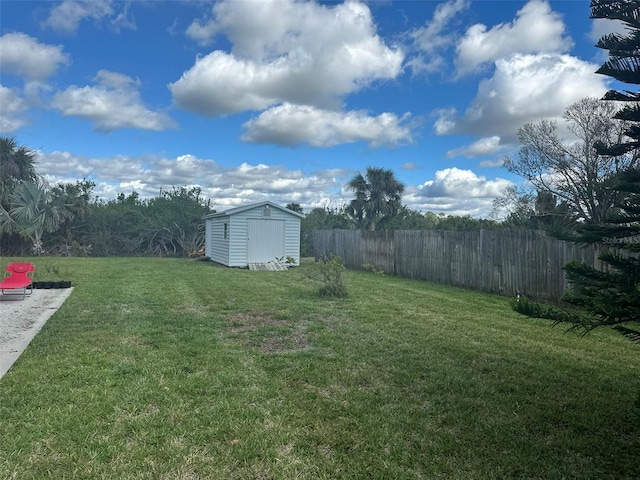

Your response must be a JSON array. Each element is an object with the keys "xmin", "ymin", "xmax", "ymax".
[{"xmin": 0, "ymin": 137, "xmax": 508, "ymax": 256}]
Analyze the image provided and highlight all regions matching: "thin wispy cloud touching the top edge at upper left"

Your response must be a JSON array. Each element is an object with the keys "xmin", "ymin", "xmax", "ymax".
[{"xmin": 43, "ymin": 0, "xmax": 136, "ymax": 35}]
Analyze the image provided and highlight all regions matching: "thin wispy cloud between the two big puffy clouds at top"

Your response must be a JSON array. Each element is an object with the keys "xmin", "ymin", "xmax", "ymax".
[{"xmin": 407, "ymin": 0, "xmax": 471, "ymax": 73}]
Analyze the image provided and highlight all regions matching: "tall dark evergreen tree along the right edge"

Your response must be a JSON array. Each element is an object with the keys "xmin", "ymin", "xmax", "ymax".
[{"xmin": 565, "ymin": 0, "xmax": 640, "ymax": 329}]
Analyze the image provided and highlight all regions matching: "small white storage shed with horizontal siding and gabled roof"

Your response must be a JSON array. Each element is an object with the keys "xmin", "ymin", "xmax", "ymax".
[{"xmin": 204, "ymin": 202, "xmax": 304, "ymax": 267}]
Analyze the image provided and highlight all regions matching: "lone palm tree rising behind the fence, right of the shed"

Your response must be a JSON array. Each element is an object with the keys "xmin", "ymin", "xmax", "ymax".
[{"xmin": 347, "ymin": 167, "xmax": 404, "ymax": 231}]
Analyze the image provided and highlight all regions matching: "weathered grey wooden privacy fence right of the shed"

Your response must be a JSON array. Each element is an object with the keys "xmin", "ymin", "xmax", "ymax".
[{"xmin": 313, "ymin": 230, "xmax": 606, "ymax": 302}]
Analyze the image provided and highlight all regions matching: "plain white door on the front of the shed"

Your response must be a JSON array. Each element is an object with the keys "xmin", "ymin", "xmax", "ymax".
[{"xmin": 247, "ymin": 218, "xmax": 284, "ymax": 263}]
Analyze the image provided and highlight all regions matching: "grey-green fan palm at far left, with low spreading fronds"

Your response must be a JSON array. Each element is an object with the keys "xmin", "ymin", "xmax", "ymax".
[{"xmin": 0, "ymin": 179, "xmax": 70, "ymax": 255}]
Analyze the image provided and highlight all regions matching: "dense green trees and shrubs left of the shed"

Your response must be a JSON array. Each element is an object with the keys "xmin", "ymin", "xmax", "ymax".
[{"xmin": 0, "ymin": 141, "xmax": 214, "ymax": 256}]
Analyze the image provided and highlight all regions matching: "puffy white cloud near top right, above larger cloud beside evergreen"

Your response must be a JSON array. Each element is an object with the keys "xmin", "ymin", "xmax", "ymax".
[{"xmin": 455, "ymin": 0, "xmax": 573, "ymax": 76}]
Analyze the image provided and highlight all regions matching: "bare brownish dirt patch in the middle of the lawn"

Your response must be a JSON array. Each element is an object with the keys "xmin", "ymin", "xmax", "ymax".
[{"xmin": 227, "ymin": 312, "xmax": 309, "ymax": 353}]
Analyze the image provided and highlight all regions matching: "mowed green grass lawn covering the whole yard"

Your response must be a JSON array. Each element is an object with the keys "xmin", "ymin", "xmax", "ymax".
[{"xmin": 0, "ymin": 258, "xmax": 640, "ymax": 480}]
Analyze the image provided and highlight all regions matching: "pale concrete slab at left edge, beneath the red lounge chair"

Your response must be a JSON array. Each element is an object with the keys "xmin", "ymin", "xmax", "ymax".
[{"xmin": 0, "ymin": 288, "xmax": 73, "ymax": 378}]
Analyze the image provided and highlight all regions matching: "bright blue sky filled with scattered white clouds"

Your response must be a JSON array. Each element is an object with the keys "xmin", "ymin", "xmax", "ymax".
[{"xmin": 0, "ymin": 0, "xmax": 618, "ymax": 217}]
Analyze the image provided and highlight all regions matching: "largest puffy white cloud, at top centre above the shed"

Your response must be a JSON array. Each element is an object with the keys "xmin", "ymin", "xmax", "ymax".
[{"xmin": 169, "ymin": 0, "xmax": 404, "ymax": 116}]
